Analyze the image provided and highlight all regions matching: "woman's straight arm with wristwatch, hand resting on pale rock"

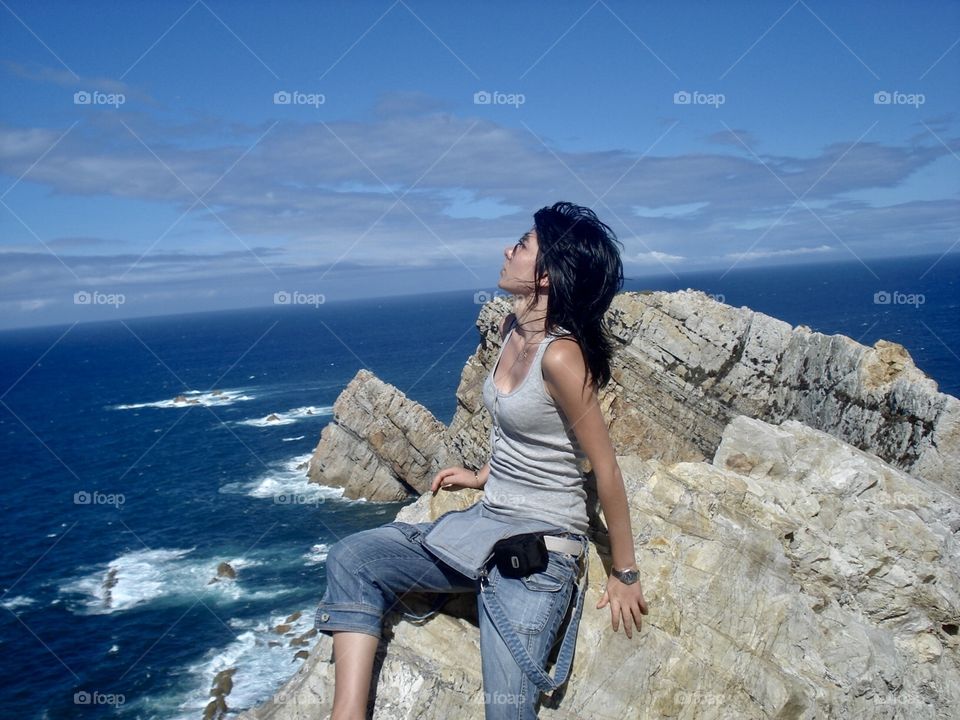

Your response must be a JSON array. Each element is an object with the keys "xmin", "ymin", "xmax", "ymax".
[{"xmin": 542, "ymin": 339, "xmax": 648, "ymax": 637}]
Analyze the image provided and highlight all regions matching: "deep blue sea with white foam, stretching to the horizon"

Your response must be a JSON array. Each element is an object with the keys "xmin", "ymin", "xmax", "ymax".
[{"xmin": 0, "ymin": 252, "xmax": 960, "ymax": 720}]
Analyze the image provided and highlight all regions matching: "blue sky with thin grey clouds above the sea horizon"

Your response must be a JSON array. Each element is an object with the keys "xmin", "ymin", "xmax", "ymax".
[{"xmin": 0, "ymin": 0, "xmax": 960, "ymax": 327}]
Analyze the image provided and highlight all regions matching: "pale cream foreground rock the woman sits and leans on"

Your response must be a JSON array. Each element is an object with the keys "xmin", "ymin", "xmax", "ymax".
[{"xmin": 242, "ymin": 416, "xmax": 960, "ymax": 720}]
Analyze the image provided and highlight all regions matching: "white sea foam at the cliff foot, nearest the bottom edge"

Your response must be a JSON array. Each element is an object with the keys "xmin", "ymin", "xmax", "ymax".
[{"xmin": 168, "ymin": 607, "xmax": 317, "ymax": 720}]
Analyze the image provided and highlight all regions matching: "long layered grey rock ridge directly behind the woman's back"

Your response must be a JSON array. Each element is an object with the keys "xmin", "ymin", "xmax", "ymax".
[{"xmin": 447, "ymin": 290, "xmax": 960, "ymax": 494}]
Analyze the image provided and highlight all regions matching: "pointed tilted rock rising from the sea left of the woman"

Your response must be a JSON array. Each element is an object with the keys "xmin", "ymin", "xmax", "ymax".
[{"xmin": 308, "ymin": 370, "xmax": 457, "ymax": 502}]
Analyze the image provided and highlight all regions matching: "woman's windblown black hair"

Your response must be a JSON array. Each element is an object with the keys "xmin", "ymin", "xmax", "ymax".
[{"xmin": 533, "ymin": 202, "xmax": 623, "ymax": 390}]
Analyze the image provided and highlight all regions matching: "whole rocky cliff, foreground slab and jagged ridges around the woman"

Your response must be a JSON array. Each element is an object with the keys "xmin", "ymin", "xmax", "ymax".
[{"xmin": 245, "ymin": 291, "xmax": 960, "ymax": 720}]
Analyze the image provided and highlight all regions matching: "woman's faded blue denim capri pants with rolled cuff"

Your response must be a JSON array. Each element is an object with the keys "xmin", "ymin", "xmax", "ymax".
[{"xmin": 315, "ymin": 521, "xmax": 583, "ymax": 720}]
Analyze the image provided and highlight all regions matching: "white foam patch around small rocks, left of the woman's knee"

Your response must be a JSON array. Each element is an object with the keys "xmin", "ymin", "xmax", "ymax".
[{"xmin": 60, "ymin": 548, "xmax": 292, "ymax": 615}]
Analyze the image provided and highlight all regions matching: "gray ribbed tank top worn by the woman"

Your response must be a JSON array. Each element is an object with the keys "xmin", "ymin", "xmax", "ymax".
[{"xmin": 483, "ymin": 316, "xmax": 588, "ymax": 534}]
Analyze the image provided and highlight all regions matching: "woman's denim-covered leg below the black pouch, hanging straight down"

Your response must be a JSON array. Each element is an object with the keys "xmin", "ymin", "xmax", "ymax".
[{"xmin": 477, "ymin": 551, "xmax": 577, "ymax": 720}]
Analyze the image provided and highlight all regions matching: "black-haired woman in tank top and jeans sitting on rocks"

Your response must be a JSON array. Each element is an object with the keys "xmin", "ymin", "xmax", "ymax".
[{"xmin": 316, "ymin": 202, "xmax": 648, "ymax": 720}]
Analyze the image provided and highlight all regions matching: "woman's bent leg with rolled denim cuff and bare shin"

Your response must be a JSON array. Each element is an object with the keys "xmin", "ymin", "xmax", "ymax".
[{"xmin": 314, "ymin": 522, "xmax": 476, "ymax": 720}]
